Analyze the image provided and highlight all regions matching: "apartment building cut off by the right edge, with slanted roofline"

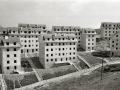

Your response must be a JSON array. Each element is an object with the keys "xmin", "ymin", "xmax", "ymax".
[{"xmin": 110, "ymin": 32, "xmax": 120, "ymax": 56}]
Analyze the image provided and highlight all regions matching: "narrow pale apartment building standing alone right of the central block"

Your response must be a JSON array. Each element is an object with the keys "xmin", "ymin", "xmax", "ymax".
[{"xmin": 81, "ymin": 28, "xmax": 96, "ymax": 51}]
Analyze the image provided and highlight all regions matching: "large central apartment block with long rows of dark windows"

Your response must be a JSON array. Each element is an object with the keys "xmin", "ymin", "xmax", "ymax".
[{"xmin": 39, "ymin": 34, "xmax": 77, "ymax": 68}]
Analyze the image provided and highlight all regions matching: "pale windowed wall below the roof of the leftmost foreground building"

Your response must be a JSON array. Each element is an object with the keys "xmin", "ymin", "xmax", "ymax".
[{"xmin": 2, "ymin": 48, "xmax": 21, "ymax": 74}]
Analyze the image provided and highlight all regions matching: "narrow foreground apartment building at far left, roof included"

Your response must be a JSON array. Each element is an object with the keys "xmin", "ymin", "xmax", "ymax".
[{"xmin": 0, "ymin": 37, "xmax": 21, "ymax": 74}]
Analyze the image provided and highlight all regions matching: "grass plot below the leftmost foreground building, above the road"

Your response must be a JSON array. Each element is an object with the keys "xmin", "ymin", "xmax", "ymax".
[{"xmin": 5, "ymin": 73, "xmax": 38, "ymax": 90}]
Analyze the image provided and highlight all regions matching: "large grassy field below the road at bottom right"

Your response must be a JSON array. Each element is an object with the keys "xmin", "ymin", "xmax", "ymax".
[{"xmin": 36, "ymin": 65, "xmax": 120, "ymax": 90}]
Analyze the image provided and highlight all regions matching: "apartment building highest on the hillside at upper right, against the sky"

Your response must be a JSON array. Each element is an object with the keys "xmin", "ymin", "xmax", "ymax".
[{"xmin": 100, "ymin": 22, "xmax": 120, "ymax": 40}]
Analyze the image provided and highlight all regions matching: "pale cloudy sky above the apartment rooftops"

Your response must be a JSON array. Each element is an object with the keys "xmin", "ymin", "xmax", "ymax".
[{"xmin": 0, "ymin": 0, "xmax": 120, "ymax": 29}]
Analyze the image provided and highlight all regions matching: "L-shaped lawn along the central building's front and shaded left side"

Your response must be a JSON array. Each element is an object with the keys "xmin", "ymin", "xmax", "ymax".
[{"xmin": 31, "ymin": 57, "xmax": 77, "ymax": 80}]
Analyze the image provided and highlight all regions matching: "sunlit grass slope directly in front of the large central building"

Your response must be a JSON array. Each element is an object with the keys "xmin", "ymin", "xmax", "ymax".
[{"xmin": 37, "ymin": 65, "xmax": 77, "ymax": 80}]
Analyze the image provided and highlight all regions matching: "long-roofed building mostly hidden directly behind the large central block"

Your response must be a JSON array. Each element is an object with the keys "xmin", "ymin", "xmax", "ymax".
[{"xmin": 52, "ymin": 26, "xmax": 81, "ymax": 47}]
